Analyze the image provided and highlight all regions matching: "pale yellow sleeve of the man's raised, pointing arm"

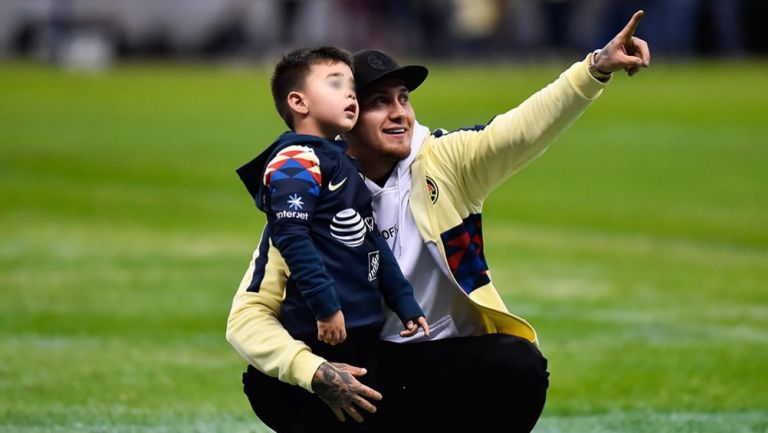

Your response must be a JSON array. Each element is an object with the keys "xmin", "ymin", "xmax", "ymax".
[{"xmin": 432, "ymin": 55, "xmax": 605, "ymax": 209}]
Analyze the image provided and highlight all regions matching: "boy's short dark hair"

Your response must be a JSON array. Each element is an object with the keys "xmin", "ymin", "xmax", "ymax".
[{"xmin": 272, "ymin": 47, "xmax": 352, "ymax": 129}]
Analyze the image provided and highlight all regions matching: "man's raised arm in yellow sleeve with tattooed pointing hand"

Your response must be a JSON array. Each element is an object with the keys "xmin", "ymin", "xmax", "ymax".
[{"xmin": 433, "ymin": 11, "xmax": 650, "ymax": 203}]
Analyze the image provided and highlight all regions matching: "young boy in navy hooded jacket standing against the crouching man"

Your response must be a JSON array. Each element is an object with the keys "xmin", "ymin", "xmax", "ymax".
[{"xmin": 237, "ymin": 47, "xmax": 429, "ymax": 426}]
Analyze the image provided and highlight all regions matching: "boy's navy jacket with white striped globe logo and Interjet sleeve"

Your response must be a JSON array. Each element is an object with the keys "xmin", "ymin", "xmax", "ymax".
[{"xmin": 237, "ymin": 132, "xmax": 423, "ymax": 339}]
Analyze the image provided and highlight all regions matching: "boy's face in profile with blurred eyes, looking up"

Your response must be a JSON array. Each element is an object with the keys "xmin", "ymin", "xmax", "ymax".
[{"xmin": 302, "ymin": 62, "xmax": 359, "ymax": 138}]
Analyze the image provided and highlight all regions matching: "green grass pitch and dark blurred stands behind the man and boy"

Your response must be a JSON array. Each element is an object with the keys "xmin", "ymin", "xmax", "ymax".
[{"xmin": 0, "ymin": 0, "xmax": 768, "ymax": 433}]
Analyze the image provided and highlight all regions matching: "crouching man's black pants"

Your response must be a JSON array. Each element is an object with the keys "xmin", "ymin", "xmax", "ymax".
[{"xmin": 243, "ymin": 334, "xmax": 549, "ymax": 433}]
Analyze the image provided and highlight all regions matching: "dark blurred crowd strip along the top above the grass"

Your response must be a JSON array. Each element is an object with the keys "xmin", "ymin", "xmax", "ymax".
[{"xmin": 0, "ymin": 0, "xmax": 768, "ymax": 67}]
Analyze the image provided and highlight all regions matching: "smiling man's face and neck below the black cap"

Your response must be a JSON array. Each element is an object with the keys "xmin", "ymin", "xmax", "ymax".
[{"xmin": 344, "ymin": 79, "xmax": 415, "ymax": 161}]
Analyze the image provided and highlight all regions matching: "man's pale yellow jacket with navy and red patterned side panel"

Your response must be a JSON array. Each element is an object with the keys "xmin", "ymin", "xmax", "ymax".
[{"xmin": 226, "ymin": 56, "xmax": 604, "ymax": 391}]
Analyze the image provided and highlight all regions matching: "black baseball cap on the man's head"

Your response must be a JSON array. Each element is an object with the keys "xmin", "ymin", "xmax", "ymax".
[{"xmin": 352, "ymin": 50, "xmax": 429, "ymax": 94}]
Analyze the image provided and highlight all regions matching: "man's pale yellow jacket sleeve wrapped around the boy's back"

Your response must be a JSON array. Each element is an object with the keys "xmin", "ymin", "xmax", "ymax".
[{"xmin": 227, "ymin": 231, "xmax": 325, "ymax": 392}]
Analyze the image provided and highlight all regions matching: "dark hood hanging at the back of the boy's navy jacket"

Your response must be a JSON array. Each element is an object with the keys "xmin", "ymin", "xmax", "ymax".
[{"xmin": 235, "ymin": 131, "xmax": 328, "ymax": 211}]
